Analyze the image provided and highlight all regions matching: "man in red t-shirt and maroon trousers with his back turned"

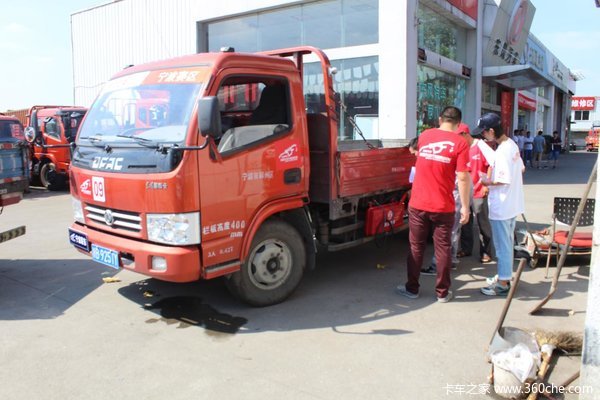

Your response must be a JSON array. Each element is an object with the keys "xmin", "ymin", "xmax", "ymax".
[{"xmin": 396, "ymin": 106, "xmax": 470, "ymax": 303}]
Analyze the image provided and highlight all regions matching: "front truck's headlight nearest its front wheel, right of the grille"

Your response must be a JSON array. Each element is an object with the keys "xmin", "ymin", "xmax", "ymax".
[{"xmin": 146, "ymin": 213, "xmax": 200, "ymax": 245}]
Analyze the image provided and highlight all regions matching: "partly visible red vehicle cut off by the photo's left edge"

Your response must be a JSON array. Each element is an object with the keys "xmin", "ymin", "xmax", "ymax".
[{"xmin": 0, "ymin": 113, "xmax": 29, "ymax": 243}]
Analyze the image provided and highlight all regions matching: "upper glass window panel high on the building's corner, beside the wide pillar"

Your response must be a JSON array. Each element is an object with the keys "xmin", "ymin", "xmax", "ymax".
[{"xmin": 417, "ymin": 4, "xmax": 467, "ymax": 64}]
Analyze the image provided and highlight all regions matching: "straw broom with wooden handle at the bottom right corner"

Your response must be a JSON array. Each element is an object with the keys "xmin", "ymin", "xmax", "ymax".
[{"xmin": 527, "ymin": 331, "xmax": 583, "ymax": 400}]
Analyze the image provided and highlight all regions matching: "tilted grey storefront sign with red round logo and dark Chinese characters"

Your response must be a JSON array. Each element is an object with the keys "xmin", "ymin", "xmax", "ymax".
[{"xmin": 484, "ymin": 0, "xmax": 535, "ymax": 66}]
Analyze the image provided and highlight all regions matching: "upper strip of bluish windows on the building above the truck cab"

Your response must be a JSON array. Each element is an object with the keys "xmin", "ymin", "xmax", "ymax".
[{"xmin": 208, "ymin": 0, "xmax": 379, "ymax": 52}]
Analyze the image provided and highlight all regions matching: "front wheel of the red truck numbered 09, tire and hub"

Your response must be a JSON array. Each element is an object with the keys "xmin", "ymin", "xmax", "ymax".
[{"xmin": 226, "ymin": 220, "xmax": 306, "ymax": 307}]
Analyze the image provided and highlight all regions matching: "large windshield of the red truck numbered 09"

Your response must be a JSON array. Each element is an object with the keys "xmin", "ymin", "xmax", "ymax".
[{"xmin": 78, "ymin": 67, "xmax": 209, "ymax": 144}]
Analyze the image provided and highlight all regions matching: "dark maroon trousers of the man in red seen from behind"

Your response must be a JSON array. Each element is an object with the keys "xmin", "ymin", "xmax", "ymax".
[{"xmin": 406, "ymin": 207, "xmax": 454, "ymax": 297}]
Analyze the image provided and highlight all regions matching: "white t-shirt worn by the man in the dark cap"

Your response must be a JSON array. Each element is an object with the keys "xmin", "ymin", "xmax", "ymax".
[{"xmin": 488, "ymin": 140, "xmax": 525, "ymax": 220}]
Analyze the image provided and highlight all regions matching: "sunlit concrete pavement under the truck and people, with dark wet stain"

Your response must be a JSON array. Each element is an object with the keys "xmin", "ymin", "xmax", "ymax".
[{"xmin": 0, "ymin": 152, "xmax": 597, "ymax": 400}]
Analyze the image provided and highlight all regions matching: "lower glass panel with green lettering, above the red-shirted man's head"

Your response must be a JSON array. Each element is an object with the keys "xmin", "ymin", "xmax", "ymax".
[{"xmin": 417, "ymin": 65, "xmax": 466, "ymax": 133}]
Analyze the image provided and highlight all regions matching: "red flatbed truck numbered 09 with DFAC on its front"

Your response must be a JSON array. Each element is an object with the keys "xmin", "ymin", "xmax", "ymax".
[{"xmin": 64, "ymin": 47, "xmax": 415, "ymax": 306}]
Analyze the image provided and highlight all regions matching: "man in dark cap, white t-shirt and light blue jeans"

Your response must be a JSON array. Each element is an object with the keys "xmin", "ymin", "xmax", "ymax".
[{"xmin": 476, "ymin": 113, "xmax": 525, "ymax": 296}]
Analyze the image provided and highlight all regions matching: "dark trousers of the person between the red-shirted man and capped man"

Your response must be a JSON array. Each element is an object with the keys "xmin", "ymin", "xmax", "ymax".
[{"xmin": 460, "ymin": 198, "xmax": 494, "ymax": 258}]
